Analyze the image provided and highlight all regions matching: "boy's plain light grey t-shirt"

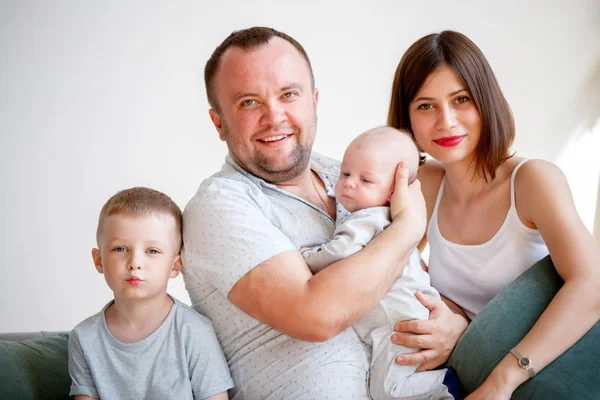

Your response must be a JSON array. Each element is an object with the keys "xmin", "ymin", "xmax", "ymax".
[{"xmin": 69, "ymin": 299, "xmax": 233, "ymax": 400}]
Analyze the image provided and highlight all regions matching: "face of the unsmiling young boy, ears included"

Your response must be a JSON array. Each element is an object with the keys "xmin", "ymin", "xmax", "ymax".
[{"xmin": 92, "ymin": 214, "xmax": 181, "ymax": 300}]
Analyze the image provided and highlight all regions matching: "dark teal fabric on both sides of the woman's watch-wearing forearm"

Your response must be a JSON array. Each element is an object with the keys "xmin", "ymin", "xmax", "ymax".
[{"xmin": 448, "ymin": 256, "xmax": 600, "ymax": 400}]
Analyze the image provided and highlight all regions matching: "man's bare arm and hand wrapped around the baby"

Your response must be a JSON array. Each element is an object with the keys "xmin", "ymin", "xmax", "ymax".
[{"xmin": 228, "ymin": 164, "xmax": 425, "ymax": 341}]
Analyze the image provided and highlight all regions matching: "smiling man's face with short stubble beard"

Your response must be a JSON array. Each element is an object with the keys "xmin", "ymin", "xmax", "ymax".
[{"xmin": 210, "ymin": 37, "xmax": 318, "ymax": 183}]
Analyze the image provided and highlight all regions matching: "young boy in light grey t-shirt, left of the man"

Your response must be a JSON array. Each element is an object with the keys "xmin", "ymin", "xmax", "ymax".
[{"xmin": 69, "ymin": 187, "xmax": 233, "ymax": 400}]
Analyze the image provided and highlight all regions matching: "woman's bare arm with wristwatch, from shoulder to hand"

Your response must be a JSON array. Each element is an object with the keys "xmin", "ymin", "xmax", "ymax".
[{"xmin": 473, "ymin": 160, "xmax": 600, "ymax": 398}]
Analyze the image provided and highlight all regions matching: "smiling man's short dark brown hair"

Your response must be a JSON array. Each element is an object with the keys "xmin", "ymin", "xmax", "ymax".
[{"xmin": 204, "ymin": 26, "xmax": 315, "ymax": 111}]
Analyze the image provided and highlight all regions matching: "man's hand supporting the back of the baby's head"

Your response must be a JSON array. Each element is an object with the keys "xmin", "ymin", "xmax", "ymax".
[{"xmin": 390, "ymin": 161, "xmax": 427, "ymax": 241}]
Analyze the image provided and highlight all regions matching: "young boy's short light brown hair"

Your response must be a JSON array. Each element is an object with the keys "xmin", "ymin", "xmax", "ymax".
[{"xmin": 96, "ymin": 187, "xmax": 182, "ymax": 248}]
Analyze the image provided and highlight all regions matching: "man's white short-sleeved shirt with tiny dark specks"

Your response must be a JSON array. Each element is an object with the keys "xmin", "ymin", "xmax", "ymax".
[{"xmin": 182, "ymin": 153, "xmax": 369, "ymax": 400}]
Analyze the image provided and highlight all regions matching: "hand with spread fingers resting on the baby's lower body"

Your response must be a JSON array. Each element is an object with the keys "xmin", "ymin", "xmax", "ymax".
[{"xmin": 392, "ymin": 292, "xmax": 468, "ymax": 372}]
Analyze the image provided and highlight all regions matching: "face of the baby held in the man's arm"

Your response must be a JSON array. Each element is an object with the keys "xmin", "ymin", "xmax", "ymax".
[{"xmin": 335, "ymin": 144, "xmax": 396, "ymax": 212}]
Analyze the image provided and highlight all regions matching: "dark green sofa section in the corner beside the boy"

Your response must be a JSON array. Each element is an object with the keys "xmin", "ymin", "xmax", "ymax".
[{"xmin": 0, "ymin": 334, "xmax": 71, "ymax": 399}]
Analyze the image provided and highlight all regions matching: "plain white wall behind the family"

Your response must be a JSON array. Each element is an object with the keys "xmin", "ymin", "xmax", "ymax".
[{"xmin": 0, "ymin": 0, "xmax": 600, "ymax": 332}]
